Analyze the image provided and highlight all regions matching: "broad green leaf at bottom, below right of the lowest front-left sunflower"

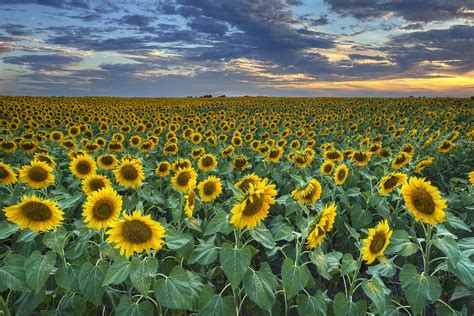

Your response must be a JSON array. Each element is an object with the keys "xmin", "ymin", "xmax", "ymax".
[{"xmin": 155, "ymin": 266, "xmax": 193, "ymax": 310}]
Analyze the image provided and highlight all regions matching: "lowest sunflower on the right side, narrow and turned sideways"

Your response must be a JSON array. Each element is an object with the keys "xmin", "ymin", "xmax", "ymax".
[{"xmin": 362, "ymin": 219, "xmax": 393, "ymax": 264}]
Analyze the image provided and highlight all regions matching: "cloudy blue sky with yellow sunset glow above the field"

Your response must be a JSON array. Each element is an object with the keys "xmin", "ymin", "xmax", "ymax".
[{"xmin": 0, "ymin": 0, "xmax": 474, "ymax": 97}]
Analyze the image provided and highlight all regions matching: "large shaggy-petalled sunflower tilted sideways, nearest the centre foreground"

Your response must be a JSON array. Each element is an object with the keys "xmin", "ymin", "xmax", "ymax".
[{"xmin": 230, "ymin": 179, "xmax": 277, "ymax": 229}]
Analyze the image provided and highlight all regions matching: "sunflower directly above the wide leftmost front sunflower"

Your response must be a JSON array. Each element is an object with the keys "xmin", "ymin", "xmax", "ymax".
[{"xmin": 19, "ymin": 160, "xmax": 55, "ymax": 189}]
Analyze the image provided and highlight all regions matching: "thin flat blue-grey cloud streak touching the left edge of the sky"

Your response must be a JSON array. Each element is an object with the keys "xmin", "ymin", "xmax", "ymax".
[{"xmin": 2, "ymin": 54, "xmax": 82, "ymax": 71}]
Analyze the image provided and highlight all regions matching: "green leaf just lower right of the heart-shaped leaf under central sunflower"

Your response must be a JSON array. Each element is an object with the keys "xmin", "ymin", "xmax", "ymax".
[{"xmin": 243, "ymin": 262, "xmax": 275, "ymax": 311}]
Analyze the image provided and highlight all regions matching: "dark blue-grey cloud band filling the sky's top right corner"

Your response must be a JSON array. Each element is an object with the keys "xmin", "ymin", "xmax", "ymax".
[{"xmin": 324, "ymin": 0, "xmax": 474, "ymax": 22}]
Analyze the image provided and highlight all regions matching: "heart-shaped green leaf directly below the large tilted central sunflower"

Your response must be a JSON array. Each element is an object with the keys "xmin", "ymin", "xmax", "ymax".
[{"xmin": 219, "ymin": 243, "xmax": 252, "ymax": 289}]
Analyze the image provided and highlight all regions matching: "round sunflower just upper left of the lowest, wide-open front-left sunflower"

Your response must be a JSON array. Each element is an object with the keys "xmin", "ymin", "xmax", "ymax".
[{"xmin": 82, "ymin": 186, "xmax": 122, "ymax": 230}]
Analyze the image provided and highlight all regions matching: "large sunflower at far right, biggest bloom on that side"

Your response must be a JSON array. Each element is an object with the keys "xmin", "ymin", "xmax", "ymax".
[{"xmin": 400, "ymin": 177, "xmax": 447, "ymax": 225}]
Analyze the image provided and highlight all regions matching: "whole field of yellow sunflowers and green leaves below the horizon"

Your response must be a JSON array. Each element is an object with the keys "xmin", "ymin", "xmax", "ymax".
[{"xmin": 0, "ymin": 97, "xmax": 474, "ymax": 316}]
